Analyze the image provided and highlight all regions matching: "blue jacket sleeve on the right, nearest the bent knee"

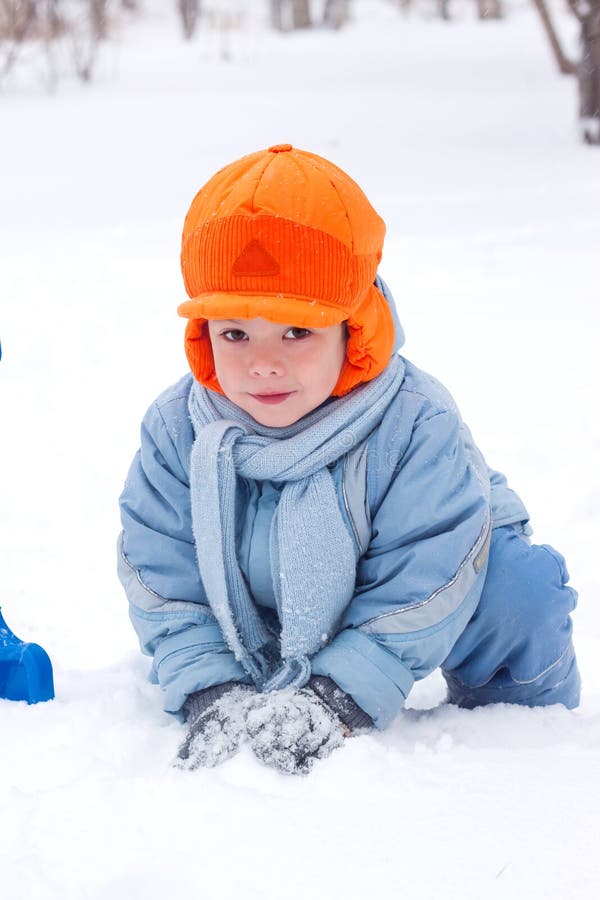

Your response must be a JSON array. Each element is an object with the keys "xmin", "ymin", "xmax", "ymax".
[{"xmin": 312, "ymin": 410, "xmax": 491, "ymax": 728}]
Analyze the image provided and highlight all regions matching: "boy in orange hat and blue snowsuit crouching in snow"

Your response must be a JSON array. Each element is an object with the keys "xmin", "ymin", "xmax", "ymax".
[{"xmin": 119, "ymin": 144, "xmax": 579, "ymax": 773}]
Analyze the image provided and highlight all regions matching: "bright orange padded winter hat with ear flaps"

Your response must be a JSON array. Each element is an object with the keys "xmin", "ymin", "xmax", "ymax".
[{"xmin": 178, "ymin": 144, "xmax": 394, "ymax": 396}]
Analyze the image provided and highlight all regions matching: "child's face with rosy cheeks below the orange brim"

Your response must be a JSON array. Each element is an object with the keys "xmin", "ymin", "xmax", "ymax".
[{"xmin": 208, "ymin": 318, "xmax": 346, "ymax": 428}]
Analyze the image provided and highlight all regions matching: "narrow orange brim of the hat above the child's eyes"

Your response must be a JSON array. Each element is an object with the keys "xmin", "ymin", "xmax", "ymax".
[{"xmin": 177, "ymin": 291, "xmax": 350, "ymax": 328}]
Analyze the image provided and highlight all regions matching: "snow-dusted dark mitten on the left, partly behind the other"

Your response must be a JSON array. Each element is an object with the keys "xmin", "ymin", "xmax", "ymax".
[{"xmin": 174, "ymin": 681, "xmax": 252, "ymax": 770}]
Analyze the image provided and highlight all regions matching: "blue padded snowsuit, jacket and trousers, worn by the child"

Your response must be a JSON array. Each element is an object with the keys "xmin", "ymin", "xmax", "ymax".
[{"xmin": 118, "ymin": 283, "xmax": 580, "ymax": 728}]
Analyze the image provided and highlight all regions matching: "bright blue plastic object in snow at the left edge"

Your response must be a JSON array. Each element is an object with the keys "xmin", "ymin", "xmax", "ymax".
[{"xmin": 0, "ymin": 612, "xmax": 54, "ymax": 703}]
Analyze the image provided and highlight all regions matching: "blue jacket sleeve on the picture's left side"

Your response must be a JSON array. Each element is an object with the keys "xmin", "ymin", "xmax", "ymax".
[{"xmin": 118, "ymin": 404, "xmax": 247, "ymax": 713}]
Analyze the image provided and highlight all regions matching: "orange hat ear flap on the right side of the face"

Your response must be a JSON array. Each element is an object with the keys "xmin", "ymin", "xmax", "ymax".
[{"xmin": 332, "ymin": 284, "xmax": 395, "ymax": 397}]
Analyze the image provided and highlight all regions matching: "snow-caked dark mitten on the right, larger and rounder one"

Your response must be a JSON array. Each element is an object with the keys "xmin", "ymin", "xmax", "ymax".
[{"xmin": 246, "ymin": 687, "xmax": 346, "ymax": 775}]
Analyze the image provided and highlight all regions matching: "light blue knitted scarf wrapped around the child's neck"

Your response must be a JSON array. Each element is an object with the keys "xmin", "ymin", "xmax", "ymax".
[{"xmin": 189, "ymin": 356, "xmax": 404, "ymax": 691}]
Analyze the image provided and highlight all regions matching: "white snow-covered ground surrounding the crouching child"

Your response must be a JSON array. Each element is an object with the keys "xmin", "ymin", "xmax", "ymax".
[{"xmin": 0, "ymin": 0, "xmax": 600, "ymax": 900}]
